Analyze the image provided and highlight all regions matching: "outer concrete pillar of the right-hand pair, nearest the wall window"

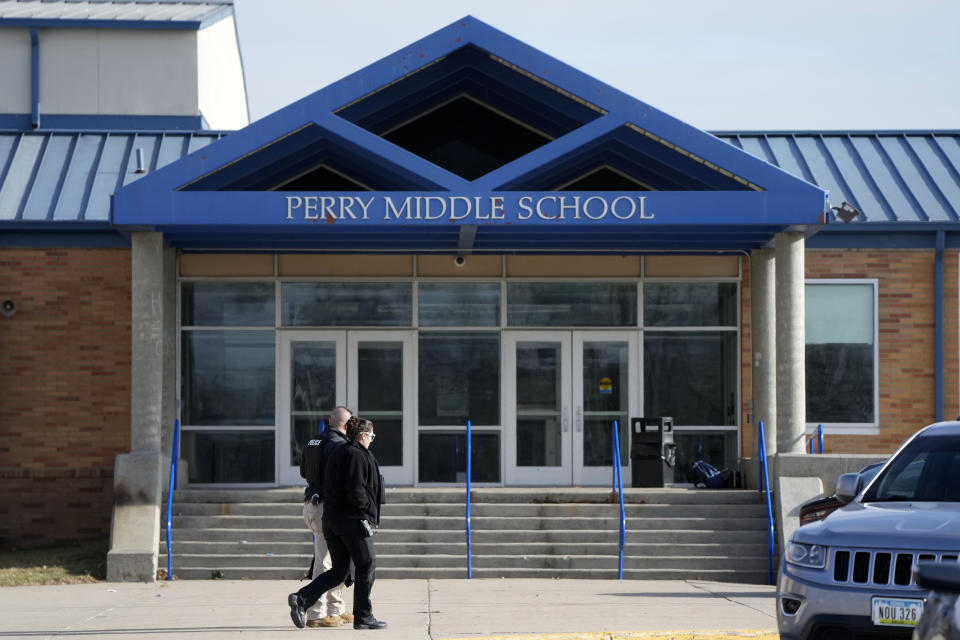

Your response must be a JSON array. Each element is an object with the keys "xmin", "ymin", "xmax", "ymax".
[{"xmin": 774, "ymin": 231, "xmax": 807, "ymax": 453}]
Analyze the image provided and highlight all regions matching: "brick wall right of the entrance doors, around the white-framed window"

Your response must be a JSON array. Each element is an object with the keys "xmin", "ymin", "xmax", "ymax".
[{"xmin": 741, "ymin": 249, "xmax": 960, "ymax": 457}]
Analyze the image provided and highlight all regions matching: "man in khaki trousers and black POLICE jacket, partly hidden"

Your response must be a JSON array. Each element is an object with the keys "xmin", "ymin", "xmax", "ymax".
[{"xmin": 300, "ymin": 406, "xmax": 353, "ymax": 627}]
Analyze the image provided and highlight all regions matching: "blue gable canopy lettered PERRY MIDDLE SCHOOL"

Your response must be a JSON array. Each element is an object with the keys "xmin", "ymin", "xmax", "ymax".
[{"xmin": 111, "ymin": 17, "xmax": 828, "ymax": 252}]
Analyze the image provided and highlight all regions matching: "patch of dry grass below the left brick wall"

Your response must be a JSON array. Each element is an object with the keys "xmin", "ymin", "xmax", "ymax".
[{"xmin": 0, "ymin": 540, "xmax": 107, "ymax": 587}]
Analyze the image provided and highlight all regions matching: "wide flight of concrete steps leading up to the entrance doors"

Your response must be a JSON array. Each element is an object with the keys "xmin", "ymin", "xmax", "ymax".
[{"xmin": 160, "ymin": 487, "xmax": 768, "ymax": 582}]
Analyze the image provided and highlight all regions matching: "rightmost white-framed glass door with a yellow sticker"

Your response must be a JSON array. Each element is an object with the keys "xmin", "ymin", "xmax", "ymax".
[{"xmin": 573, "ymin": 331, "xmax": 639, "ymax": 486}]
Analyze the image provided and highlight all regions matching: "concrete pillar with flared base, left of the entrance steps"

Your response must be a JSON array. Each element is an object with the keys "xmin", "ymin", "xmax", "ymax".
[{"xmin": 107, "ymin": 232, "xmax": 169, "ymax": 582}]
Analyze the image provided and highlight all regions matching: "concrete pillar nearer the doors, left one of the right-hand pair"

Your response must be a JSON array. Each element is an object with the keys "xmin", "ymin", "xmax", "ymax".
[{"xmin": 750, "ymin": 249, "xmax": 777, "ymax": 457}]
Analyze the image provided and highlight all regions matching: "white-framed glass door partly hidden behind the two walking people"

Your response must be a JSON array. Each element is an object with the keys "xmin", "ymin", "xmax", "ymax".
[{"xmin": 347, "ymin": 331, "xmax": 417, "ymax": 486}]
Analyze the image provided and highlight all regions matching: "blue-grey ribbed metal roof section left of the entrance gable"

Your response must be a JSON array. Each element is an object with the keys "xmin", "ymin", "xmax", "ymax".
[{"xmin": 0, "ymin": 131, "xmax": 226, "ymax": 225}]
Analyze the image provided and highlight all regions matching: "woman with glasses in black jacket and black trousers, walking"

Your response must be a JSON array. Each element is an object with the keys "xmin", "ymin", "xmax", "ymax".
[{"xmin": 287, "ymin": 419, "xmax": 387, "ymax": 629}]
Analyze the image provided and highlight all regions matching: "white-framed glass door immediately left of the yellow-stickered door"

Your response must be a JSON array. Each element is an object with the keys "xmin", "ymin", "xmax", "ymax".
[{"xmin": 503, "ymin": 331, "xmax": 573, "ymax": 486}]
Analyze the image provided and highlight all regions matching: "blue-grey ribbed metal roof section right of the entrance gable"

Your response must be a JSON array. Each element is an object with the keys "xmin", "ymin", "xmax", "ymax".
[{"xmin": 715, "ymin": 131, "xmax": 960, "ymax": 223}]
